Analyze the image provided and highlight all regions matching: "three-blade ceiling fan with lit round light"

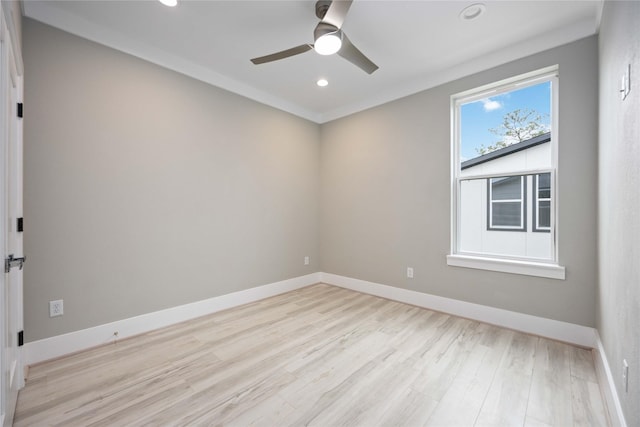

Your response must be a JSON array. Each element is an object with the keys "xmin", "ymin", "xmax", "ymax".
[{"xmin": 251, "ymin": 0, "xmax": 378, "ymax": 74}]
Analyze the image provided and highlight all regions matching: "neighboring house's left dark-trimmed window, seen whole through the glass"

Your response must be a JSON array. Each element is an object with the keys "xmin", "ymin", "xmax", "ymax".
[{"xmin": 487, "ymin": 176, "xmax": 526, "ymax": 231}]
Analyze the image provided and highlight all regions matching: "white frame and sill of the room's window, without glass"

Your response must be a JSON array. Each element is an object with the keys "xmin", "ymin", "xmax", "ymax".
[{"xmin": 447, "ymin": 65, "xmax": 565, "ymax": 280}]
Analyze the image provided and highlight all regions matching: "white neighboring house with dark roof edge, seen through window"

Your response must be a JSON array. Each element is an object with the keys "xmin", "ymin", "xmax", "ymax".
[{"xmin": 460, "ymin": 133, "xmax": 553, "ymax": 260}]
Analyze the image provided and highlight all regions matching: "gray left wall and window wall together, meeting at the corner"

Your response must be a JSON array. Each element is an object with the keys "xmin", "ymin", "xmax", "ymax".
[{"xmin": 23, "ymin": 20, "xmax": 598, "ymax": 341}]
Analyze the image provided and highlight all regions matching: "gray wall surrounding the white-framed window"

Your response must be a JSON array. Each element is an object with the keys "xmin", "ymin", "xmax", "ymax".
[{"xmin": 320, "ymin": 37, "xmax": 598, "ymax": 326}]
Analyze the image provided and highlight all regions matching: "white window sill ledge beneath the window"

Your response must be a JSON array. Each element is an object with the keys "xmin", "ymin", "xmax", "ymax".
[{"xmin": 447, "ymin": 254, "xmax": 565, "ymax": 280}]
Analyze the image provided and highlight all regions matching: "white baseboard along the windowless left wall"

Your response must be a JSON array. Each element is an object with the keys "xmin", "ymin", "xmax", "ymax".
[{"xmin": 23, "ymin": 273, "xmax": 320, "ymax": 365}]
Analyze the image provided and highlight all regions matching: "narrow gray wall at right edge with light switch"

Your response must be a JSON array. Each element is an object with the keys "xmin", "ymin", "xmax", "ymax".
[{"xmin": 597, "ymin": 1, "xmax": 640, "ymax": 426}]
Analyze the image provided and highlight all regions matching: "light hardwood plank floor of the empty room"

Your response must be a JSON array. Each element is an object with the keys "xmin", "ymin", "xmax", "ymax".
[{"xmin": 15, "ymin": 284, "xmax": 608, "ymax": 426}]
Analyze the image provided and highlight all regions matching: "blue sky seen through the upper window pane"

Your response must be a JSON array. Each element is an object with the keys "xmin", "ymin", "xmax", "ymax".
[{"xmin": 460, "ymin": 82, "xmax": 551, "ymax": 161}]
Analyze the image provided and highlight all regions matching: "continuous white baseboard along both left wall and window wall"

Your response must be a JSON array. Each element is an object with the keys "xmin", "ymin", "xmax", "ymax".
[{"xmin": 24, "ymin": 272, "xmax": 598, "ymax": 365}]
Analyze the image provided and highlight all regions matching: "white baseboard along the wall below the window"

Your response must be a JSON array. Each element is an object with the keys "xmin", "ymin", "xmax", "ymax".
[{"xmin": 320, "ymin": 273, "xmax": 597, "ymax": 348}]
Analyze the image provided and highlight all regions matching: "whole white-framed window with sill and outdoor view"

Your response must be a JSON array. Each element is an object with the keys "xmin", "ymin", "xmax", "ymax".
[{"xmin": 447, "ymin": 67, "xmax": 564, "ymax": 279}]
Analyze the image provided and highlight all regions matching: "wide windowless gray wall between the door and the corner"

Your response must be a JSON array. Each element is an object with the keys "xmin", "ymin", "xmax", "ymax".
[{"xmin": 23, "ymin": 19, "xmax": 320, "ymax": 341}]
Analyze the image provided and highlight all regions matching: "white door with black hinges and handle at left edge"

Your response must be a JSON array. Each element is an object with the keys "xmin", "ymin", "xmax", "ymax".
[{"xmin": 0, "ymin": 7, "xmax": 24, "ymax": 426}]
